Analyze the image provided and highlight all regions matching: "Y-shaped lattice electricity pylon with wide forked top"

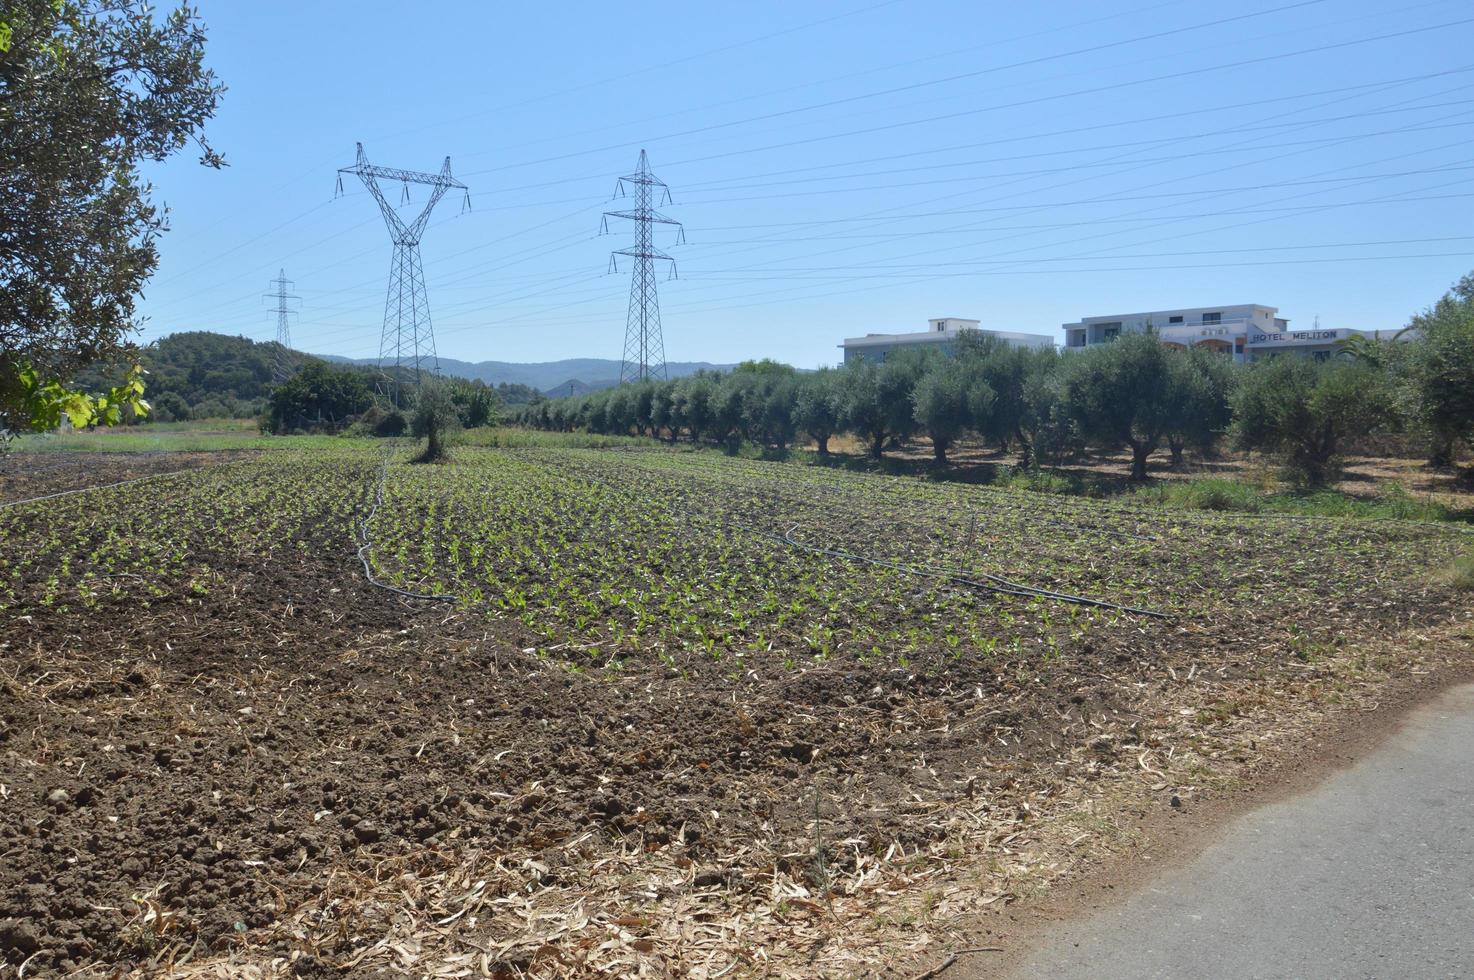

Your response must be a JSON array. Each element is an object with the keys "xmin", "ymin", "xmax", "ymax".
[{"xmin": 338, "ymin": 143, "xmax": 470, "ymax": 405}]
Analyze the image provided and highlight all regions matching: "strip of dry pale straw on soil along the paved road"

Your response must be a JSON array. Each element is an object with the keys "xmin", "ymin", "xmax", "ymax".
[{"xmin": 112, "ymin": 613, "xmax": 1474, "ymax": 979}]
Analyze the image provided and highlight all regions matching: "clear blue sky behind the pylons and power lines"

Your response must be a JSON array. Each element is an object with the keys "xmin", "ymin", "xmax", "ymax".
[{"xmin": 140, "ymin": 0, "xmax": 1474, "ymax": 367}]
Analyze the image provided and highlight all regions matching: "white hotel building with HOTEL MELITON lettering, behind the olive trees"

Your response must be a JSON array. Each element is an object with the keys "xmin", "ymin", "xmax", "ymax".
[{"xmin": 1063, "ymin": 304, "xmax": 1363, "ymax": 361}]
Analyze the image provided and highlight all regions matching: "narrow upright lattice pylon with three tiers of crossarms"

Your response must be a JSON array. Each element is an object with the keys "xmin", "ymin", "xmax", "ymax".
[{"xmin": 600, "ymin": 150, "xmax": 685, "ymax": 385}]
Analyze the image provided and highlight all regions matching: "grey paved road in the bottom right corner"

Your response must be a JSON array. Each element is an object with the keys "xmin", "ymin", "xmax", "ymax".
[{"xmin": 1016, "ymin": 685, "xmax": 1474, "ymax": 980}]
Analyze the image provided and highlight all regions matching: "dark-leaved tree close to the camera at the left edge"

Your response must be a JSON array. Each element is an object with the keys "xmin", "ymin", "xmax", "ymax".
[{"xmin": 0, "ymin": 0, "xmax": 223, "ymax": 430}]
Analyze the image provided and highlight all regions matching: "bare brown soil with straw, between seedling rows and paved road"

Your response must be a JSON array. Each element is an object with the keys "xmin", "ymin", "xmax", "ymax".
[{"xmin": 0, "ymin": 457, "xmax": 1464, "ymax": 976}]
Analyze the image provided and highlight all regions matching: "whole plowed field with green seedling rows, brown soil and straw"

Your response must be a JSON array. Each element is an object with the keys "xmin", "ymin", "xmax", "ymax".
[{"xmin": 0, "ymin": 441, "xmax": 1468, "ymax": 977}]
